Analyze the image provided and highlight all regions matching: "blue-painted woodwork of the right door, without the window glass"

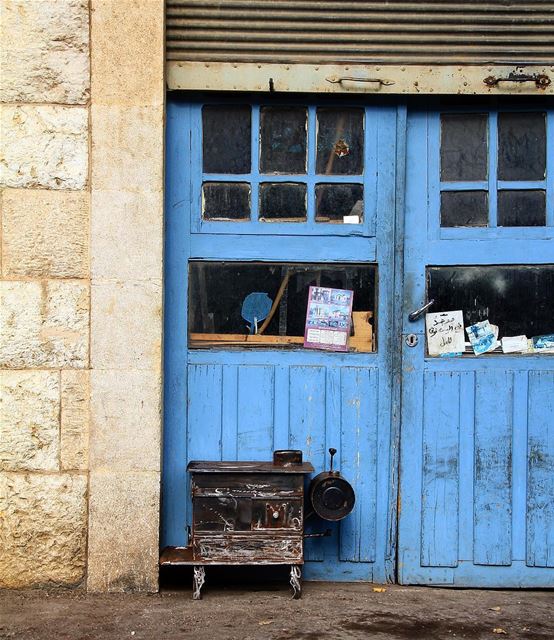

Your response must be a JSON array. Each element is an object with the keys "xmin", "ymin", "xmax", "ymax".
[{"xmin": 398, "ymin": 110, "xmax": 554, "ymax": 587}]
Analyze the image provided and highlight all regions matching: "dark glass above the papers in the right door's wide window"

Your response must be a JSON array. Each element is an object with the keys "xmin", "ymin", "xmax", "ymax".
[{"xmin": 427, "ymin": 265, "xmax": 554, "ymax": 338}]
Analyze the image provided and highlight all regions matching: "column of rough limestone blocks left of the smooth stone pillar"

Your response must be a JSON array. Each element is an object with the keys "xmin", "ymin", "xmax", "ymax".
[{"xmin": 0, "ymin": 0, "xmax": 90, "ymax": 587}]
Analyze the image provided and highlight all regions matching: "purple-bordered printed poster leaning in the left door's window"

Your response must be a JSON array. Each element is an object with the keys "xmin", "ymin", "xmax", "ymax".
[{"xmin": 304, "ymin": 287, "xmax": 354, "ymax": 351}]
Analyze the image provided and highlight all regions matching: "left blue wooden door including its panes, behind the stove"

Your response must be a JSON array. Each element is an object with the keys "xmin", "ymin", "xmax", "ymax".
[{"xmin": 162, "ymin": 98, "xmax": 403, "ymax": 581}]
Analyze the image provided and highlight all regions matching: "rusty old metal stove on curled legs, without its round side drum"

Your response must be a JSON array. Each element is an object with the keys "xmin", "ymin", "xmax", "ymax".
[{"xmin": 160, "ymin": 451, "xmax": 314, "ymax": 600}]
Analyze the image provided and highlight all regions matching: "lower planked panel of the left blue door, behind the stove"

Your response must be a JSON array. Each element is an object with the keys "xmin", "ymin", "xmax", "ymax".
[{"xmin": 181, "ymin": 354, "xmax": 379, "ymax": 563}]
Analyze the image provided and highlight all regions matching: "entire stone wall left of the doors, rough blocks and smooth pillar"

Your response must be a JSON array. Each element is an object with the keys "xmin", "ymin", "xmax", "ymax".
[{"xmin": 0, "ymin": 0, "xmax": 164, "ymax": 591}]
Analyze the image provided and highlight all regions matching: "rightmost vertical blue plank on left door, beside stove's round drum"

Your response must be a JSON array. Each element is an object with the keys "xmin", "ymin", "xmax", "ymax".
[{"xmin": 339, "ymin": 367, "xmax": 378, "ymax": 562}]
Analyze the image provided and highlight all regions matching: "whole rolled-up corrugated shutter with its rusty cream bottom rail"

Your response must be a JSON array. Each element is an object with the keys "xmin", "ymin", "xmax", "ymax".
[{"xmin": 166, "ymin": 0, "xmax": 554, "ymax": 93}]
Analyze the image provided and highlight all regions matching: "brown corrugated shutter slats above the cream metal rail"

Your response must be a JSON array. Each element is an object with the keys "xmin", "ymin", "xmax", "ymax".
[{"xmin": 166, "ymin": 0, "xmax": 554, "ymax": 64}]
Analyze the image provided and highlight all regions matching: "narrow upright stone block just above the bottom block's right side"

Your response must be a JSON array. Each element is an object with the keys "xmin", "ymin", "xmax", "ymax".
[{"xmin": 60, "ymin": 370, "xmax": 89, "ymax": 471}]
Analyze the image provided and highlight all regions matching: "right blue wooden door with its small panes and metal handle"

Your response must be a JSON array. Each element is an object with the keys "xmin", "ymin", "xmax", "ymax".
[{"xmin": 398, "ymin": 108, "xmax": 554, "ymax": 587}]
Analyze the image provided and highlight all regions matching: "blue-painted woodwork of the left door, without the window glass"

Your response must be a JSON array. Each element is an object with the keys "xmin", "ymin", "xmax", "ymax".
[{"xmin": 162, "ymin": 99, "xmax": 398, "ymax": 582}]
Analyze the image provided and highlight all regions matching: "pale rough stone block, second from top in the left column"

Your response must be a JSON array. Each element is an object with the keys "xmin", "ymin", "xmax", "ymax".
[{"xmin": 0, "ymin": 105, "xmax": 88, "ymax": 189}]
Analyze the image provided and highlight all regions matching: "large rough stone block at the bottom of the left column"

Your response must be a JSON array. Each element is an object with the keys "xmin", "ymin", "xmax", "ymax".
[{"xmin": 0, "ymin": 472, "xmax": 87, "ymax": 588}]
